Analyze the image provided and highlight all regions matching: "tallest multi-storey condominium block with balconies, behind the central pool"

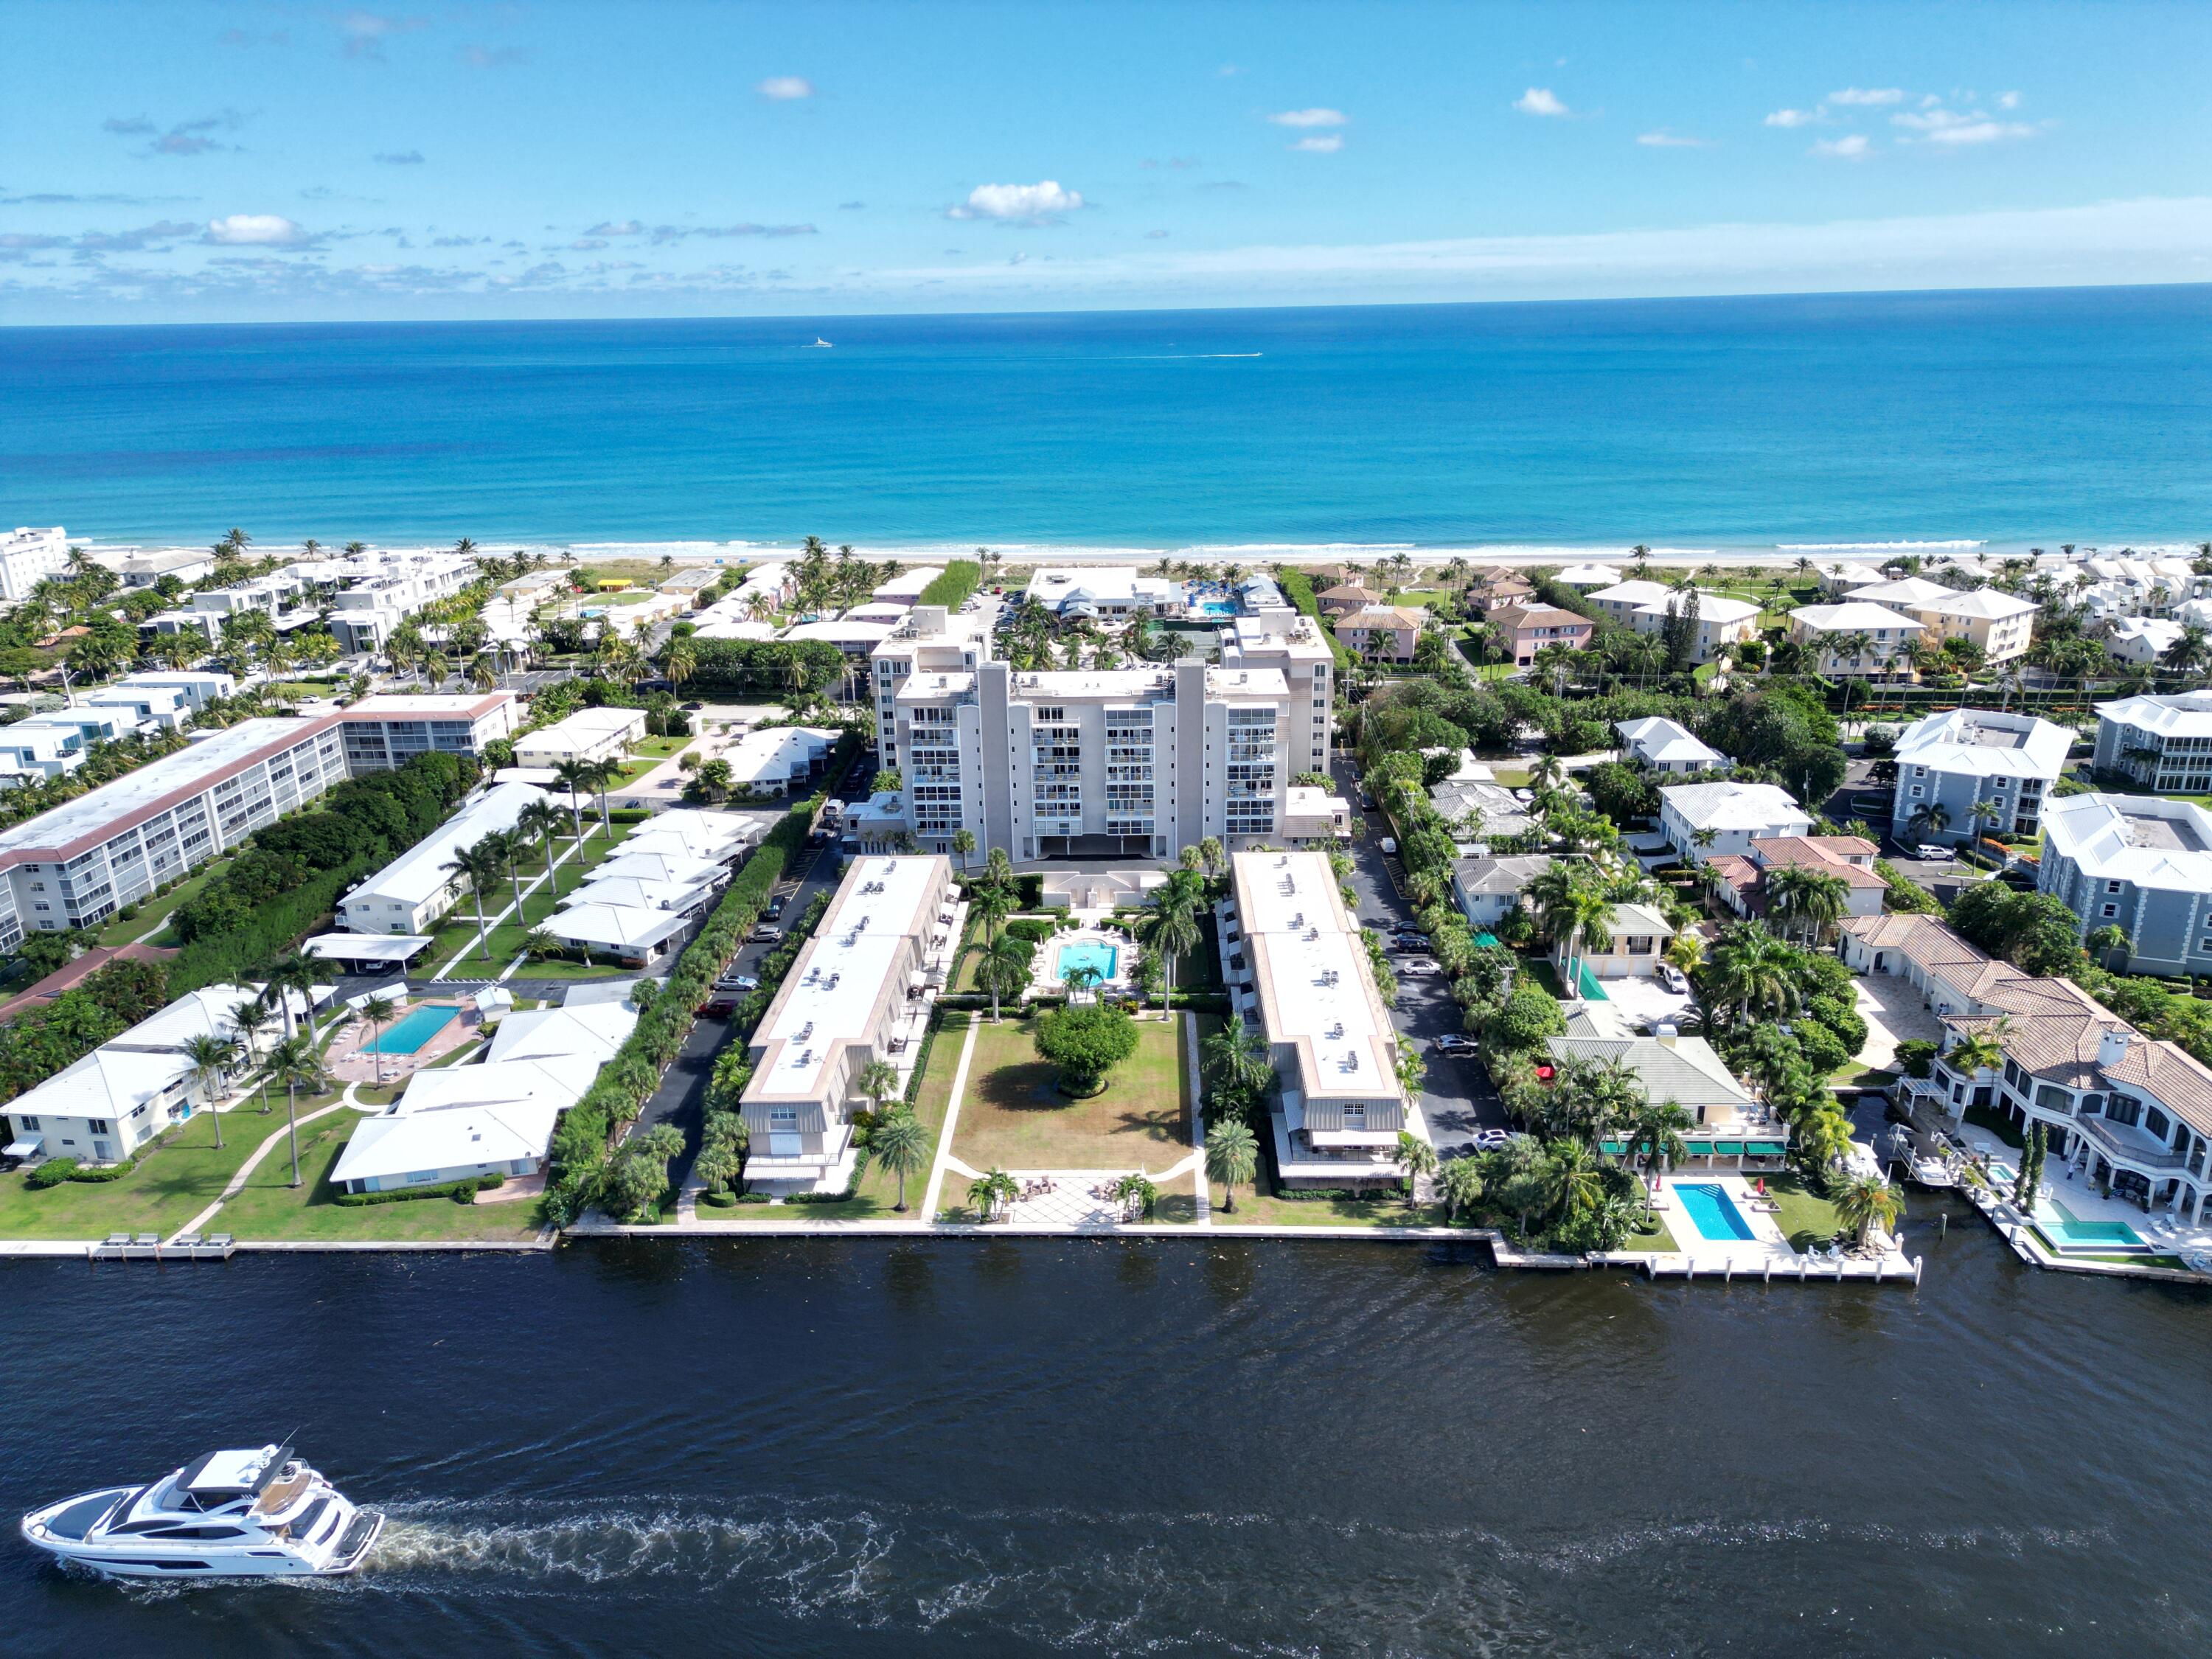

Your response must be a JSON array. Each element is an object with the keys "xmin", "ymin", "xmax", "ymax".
[{"xmin": 896, "ymin": 659, "xmax": 1307, "ymax": 860}]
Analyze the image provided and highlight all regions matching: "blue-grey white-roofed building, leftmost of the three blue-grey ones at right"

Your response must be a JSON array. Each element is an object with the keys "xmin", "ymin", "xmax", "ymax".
[{"xmin": 1889, "ymin": 708, "xmax": 2073, "ymax": 841}]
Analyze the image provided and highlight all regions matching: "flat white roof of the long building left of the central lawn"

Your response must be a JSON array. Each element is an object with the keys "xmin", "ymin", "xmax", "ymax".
[{"xmin": 745, "ymin": 858, "xmax": 945, "ymax": 1099}]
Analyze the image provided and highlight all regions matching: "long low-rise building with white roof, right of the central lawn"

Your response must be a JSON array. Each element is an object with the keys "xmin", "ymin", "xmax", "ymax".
[{"xmin": 1230, "ymin": 852, "xmax": 1429, "ymax": 1186}]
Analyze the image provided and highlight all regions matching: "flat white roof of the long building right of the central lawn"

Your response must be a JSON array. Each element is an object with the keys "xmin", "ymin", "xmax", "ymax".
[{"xmin": 1234, "ymin": 852, "xmax": 1402, "ymax": 1099}]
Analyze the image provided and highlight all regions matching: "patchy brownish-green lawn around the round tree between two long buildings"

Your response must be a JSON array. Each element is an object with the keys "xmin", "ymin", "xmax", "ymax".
[{"xmin": 953, "ymin": 1015, "xmax": 1190, "ymax": 1170}]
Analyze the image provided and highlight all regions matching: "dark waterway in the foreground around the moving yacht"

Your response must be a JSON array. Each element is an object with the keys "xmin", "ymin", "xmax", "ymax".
[{"xmin": 0, "ymin": 1221, "xmax": 2212, "ymax": 1659}]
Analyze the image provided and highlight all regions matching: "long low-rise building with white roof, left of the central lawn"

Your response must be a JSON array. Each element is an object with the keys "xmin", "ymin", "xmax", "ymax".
[{"xmin": 739, "ymin": 856, "xmax": 953, "ymax": 1192}]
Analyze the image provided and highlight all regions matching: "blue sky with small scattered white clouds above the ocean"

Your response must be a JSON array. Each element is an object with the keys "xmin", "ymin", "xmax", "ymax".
[{"xmin": 0, "ymin": 0, "xmax": 2212, "ymax": 323}]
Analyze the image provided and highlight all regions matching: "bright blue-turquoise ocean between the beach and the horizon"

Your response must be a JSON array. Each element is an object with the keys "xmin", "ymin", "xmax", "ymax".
[{"xmin": 0, "ymin": 285, "xmax": 2212, "ymax": 557}]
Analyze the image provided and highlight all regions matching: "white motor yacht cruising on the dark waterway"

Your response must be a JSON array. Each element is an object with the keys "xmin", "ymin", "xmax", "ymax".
[{"xmin": 22, "ymin": 1444, "xmax": 385, "ymax": 1579}]
